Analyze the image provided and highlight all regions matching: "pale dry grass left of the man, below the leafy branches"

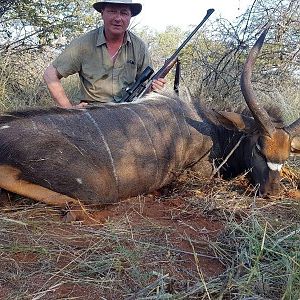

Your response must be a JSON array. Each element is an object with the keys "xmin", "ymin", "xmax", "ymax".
[{"xmin": 0, "ymin": 50, "xmax": 80, "ymax": 111}]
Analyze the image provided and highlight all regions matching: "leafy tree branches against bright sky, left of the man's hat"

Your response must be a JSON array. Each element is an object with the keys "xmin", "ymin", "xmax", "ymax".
[{"xmin": 0, "ymin": 0, "xmax": 98, "ymax": 53}]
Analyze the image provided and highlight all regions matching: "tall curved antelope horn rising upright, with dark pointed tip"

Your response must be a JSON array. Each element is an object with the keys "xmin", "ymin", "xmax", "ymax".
[{"xmin": 241, "ymin": 27, "xmax": 275, "ymax": 136}]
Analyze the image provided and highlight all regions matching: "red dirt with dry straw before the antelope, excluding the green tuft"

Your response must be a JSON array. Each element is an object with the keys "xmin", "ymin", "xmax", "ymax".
[{"xmin": 0, "ymin": 170, "xmax": 299, "ymax": 300}]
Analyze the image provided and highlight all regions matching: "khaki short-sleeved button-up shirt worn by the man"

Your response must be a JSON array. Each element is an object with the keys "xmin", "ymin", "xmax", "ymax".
[{"xmin": 52, "ymin": 26, "xmax": 152, "ymax": 102}]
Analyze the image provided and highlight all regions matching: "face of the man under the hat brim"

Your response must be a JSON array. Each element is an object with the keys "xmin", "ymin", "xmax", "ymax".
[{"xmin": 102, "ymin": 4, "xmax": 131, "ymax": 35}]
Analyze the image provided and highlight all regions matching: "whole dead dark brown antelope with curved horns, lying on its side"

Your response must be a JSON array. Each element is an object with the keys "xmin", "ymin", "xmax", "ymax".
[{"xmin": 0, "ymin": 31, "xmax": 300, "ymax": 210}]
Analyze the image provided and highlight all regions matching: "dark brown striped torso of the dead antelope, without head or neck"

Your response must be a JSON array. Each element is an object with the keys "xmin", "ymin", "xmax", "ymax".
[{"xmin": 0, "ymin": 96, "xmax": 210, "ymax": 203}]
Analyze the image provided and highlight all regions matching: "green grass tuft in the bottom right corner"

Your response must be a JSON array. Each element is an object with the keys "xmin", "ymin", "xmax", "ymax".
[{"xmin": 216, "ymin": 215, "xmax": 300, "ymax": 299}]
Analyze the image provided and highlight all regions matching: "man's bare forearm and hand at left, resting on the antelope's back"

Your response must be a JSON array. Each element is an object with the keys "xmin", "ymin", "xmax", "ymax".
[{"xmin": 44, "ymin": 65, "xmax": 86, "ymax": 108}]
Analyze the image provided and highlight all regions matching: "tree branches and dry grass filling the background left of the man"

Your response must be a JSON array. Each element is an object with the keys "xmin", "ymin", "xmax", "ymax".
[{"xmin": 0, "ymin": 0, "xmax": 99, "ymax": 111}]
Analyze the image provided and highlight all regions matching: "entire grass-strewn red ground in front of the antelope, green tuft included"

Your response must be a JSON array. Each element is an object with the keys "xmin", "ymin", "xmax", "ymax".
[{"xmin": 0, "ymin": 161, "xmax": 300, "ymax": 300}]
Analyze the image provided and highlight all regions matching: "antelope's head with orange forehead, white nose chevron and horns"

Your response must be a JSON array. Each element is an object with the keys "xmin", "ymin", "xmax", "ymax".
[{"xmin": 241, "ymin": 28, "xmax": 300, "ymax": 196}]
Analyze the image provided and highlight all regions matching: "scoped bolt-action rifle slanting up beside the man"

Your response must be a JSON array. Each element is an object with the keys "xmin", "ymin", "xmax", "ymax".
[{"xmin": 120, "ymin": 8, "xmax": 215, "ymax": 102}]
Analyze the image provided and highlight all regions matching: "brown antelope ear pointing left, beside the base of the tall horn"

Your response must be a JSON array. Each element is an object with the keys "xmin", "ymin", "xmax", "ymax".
[{"xmin": 214, "ymin": 111, "xmax": 256, "ymax": 132}]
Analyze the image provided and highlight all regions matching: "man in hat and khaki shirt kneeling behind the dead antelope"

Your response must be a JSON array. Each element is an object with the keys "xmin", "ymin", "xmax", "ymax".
[{"xmin": 44, "ymin": 0, "xmax": 166, "ymax": 108}]
